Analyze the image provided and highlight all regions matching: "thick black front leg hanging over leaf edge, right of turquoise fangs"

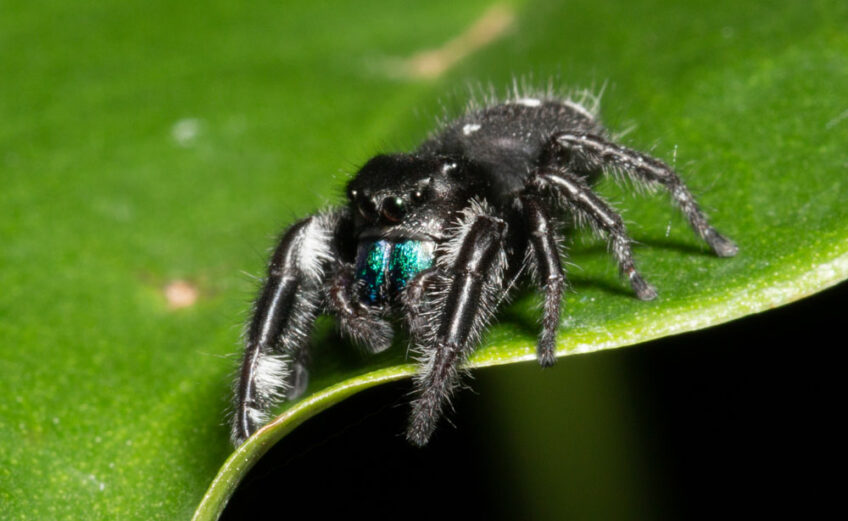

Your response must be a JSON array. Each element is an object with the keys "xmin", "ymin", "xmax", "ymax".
[{"xmin": 406, "ymin": 204, "xmax": 506, "ymax": 446}]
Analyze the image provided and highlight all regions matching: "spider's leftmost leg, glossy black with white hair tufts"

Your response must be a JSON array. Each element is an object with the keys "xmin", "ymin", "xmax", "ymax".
[{"xmin": 231, "ymin": 211, "xmax": 347, "ymax": 446}]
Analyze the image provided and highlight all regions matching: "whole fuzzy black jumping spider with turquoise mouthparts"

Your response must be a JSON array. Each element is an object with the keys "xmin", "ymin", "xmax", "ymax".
[{"xmin": 232, "ymin": 92, "xmax": 737, "ymax": 445}]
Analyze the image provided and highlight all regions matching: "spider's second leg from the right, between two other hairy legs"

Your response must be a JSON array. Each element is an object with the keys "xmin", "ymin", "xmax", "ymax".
[{"xmin": 529, "ymin": 169, "xmax": 657, "ymax": 300}]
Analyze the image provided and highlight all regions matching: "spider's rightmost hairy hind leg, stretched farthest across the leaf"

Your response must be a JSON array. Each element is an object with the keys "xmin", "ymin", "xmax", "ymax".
[{"xmin": 554, "ymin": 132, "xmax": 739, "ymax": 257}]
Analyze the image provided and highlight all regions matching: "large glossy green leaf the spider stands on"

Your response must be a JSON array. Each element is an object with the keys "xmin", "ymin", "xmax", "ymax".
[{"xmin": 0, "ymin": 0, "xmax": 848, "ymax": 520}]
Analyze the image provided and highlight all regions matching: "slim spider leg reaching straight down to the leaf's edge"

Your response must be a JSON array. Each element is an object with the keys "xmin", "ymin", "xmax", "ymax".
[{"xmin": 521, "ymin": 193, "xmax": 565, "ymax": 367}]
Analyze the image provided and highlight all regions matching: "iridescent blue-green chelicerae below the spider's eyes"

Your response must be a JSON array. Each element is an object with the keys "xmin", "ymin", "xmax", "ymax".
[{"xmin": 356, "ymin": 240, "xmax": 435, "ymax": 304}]
